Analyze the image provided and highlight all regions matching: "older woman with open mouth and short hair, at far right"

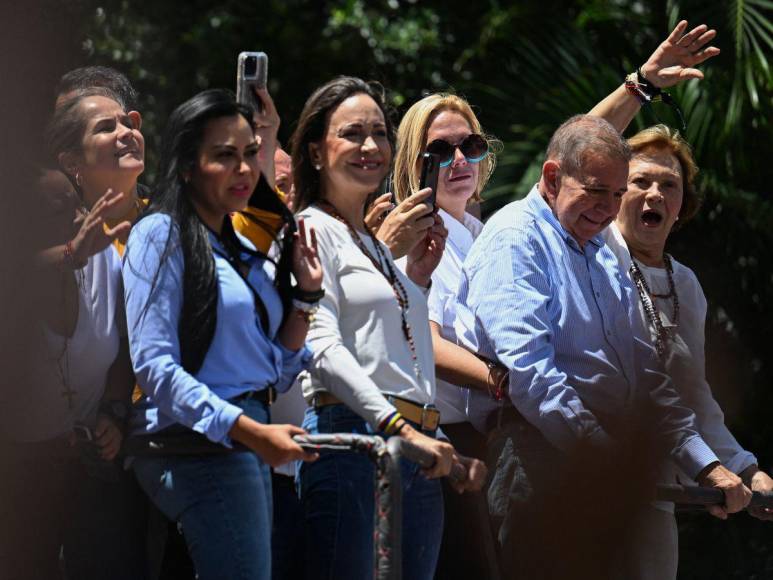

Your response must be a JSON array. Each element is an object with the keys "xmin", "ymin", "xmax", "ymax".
[{"xmin": 605, "ymin": 125, "xmax": 773, "ymax": 578}]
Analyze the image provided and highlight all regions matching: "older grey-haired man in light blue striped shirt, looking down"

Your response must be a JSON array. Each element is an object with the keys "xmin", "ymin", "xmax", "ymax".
[{"xmin": 456, "ymin": 115, "xmax": 749, "ymax": 578}]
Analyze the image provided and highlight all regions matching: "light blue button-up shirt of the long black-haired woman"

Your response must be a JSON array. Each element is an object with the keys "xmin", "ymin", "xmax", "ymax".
[{"xmin": 123, "ymin": 214, "xmax": 311, "ymax": 446}]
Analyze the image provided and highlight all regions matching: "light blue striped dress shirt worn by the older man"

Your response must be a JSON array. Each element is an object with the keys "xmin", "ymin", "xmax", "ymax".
[{"xmin": 456, "ymin": 186, "xmax": 716, "ymax": 476}]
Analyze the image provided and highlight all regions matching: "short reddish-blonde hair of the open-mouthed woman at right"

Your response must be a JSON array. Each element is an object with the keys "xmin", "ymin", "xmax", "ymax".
[{"xmin": 628, "ymin": 125, "xmax": 703, "ymax": 229}]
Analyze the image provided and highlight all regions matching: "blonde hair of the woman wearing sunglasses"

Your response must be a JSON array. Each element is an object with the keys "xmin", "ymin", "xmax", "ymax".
[{"xmin": 392, "ymin": 93, "xmax": 501, "ymax": 201}]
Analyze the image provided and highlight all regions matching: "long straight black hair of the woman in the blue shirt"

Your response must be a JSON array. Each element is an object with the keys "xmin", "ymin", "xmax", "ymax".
[{"xmin": 136, "ymin": 89, "xmax": 295, "ymax": 374}]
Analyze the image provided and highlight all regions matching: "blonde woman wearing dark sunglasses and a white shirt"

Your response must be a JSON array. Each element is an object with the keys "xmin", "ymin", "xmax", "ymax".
[{"xmin": 390, "ymin": 94, "xmax": 507, "ymax": 578}]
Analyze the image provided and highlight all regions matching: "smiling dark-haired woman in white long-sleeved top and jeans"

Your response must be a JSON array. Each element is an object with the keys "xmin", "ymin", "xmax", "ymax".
[{"xmin": 292, "ymin": 77, "xmax": 479, "ymax": 580}]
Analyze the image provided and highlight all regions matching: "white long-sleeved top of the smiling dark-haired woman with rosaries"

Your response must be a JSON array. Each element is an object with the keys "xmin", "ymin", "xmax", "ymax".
[{"xmin": 300, "ymin": 207, "xmax": 435, "ymax": 428}]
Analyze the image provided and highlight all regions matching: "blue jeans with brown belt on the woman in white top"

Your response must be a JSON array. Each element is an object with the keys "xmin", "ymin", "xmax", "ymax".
[{"xmin": 300, "ymin": 405, "xmax": 443, "ymax": 580}]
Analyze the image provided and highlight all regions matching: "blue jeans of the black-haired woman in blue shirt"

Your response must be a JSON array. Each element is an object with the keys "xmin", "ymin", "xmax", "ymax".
[{"xmin": 133, "ymin": 400, "xmax": 271, "ymax": 580}]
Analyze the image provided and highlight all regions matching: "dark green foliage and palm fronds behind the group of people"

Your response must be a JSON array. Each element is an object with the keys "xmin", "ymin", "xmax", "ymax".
[{"xmin": 66, "ymin": 0, "xmax": 773, "ymax": 579}]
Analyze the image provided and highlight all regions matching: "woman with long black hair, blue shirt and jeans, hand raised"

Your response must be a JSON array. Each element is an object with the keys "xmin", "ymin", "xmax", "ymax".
[{"xmin": 123, "ymin": 90, "xmax": 322, "ymax": 579}]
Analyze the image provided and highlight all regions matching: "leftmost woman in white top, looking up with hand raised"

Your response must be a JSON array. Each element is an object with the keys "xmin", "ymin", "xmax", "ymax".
[{"xmin": 0, "ymin": 88, "xmax": 145, "ymax": 580}]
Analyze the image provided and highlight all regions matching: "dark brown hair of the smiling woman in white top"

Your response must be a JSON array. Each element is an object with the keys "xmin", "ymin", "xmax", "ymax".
[{"xmin": 290, "ymin": 76, "xmax": 395, "ymax": 213}]
